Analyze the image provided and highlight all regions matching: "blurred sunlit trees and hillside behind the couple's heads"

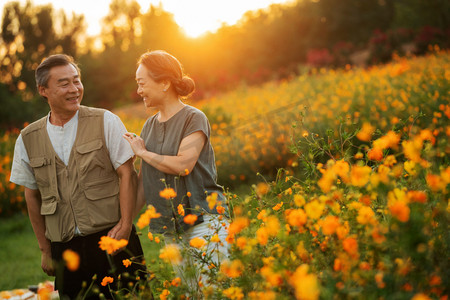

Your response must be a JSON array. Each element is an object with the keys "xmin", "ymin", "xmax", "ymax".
[{"xmin": 0, "ymin": 0, "xmax": 450, "ymax": 130}]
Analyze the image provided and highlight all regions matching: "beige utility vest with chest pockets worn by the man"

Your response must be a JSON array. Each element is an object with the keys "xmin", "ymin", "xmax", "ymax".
[{"xmin": 21, "ymin": 106, "xmax": 120, "ymax": 242}]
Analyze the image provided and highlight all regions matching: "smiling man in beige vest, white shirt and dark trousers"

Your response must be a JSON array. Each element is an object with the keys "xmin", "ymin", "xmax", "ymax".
[{"xmin": 10, "ymin": 54, "xmax": 145, "ymax": 299}]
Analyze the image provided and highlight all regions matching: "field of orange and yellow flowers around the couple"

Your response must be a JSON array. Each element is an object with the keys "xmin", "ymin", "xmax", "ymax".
[{"xmin": 0, "ymin": 49, "xmax": 450, "ymax": 300}]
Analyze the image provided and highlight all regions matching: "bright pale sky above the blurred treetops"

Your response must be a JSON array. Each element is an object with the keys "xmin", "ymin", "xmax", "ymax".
[{"xmin": 1, "ymin": 0, "xmax": 292, "ymax": 37}]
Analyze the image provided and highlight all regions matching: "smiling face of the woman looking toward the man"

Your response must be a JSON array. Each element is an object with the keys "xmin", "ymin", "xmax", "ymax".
[{"xmin": 136, "ymin": 64, "xmax": 167, "ymax": 107}]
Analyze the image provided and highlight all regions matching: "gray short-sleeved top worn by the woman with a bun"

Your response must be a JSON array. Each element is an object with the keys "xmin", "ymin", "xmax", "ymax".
[{"xmin": 141, "ymin": 105, "xmax": 226, "ymax": 233}]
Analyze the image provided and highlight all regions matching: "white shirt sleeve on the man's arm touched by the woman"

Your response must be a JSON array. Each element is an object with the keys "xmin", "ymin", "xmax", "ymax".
[{"xmin": 104, "ymin": 111, "xmax": 134, "ymax": 169}]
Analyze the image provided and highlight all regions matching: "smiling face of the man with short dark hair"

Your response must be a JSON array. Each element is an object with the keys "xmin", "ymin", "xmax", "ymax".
[{"xmin": 39, "ymin": 64, "xmax": 84, "ymax": 116}]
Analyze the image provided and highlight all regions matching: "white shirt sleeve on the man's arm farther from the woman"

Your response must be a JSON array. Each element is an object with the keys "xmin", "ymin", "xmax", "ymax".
[{"xmin": 9, "ymin": 135, "xmax": 38, "ymax": 190}]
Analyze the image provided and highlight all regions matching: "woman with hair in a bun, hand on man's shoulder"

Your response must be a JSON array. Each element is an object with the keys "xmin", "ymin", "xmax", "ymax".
[{"xmin": 124, "ymin": 51, "xmax": 228, "ymax": 294}]
